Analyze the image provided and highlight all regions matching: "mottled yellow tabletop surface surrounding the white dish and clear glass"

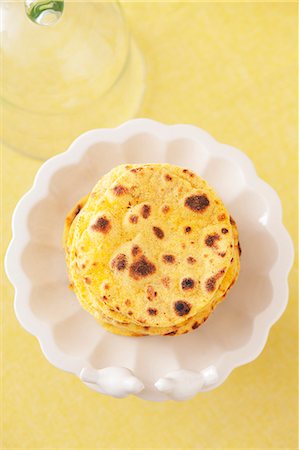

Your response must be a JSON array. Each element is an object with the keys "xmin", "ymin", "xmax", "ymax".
[{"xmin": 2, "ymin": 2, "xmax": 297, "ymax": 450}]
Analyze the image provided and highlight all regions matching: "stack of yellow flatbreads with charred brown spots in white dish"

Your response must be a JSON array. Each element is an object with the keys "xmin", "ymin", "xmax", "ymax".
[{"xmin": 65, "ymin": 164, "xmax": 241, "ymax": 334}]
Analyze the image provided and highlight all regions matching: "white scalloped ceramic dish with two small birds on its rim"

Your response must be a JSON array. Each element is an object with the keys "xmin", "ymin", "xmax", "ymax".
[{"xmin": 6, "ymin": 119, "xmax": 293, "ymax": 401}]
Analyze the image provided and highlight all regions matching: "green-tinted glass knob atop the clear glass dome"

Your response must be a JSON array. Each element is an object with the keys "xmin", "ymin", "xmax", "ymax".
[{"xmin": 25, "ymin": 0, "xmax": 64, "ymax": 26}]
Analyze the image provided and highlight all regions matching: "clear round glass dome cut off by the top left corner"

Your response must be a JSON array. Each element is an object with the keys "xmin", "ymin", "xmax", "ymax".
[{"xmin": 1, "ymin": 0, "xmax": 144, "ymax": 159}]
